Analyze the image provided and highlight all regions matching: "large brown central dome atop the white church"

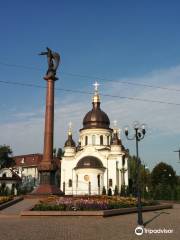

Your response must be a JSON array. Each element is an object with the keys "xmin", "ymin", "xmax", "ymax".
[{"xmin": 83, "ymin": 102, "xmax": 110, "ymax": 129}]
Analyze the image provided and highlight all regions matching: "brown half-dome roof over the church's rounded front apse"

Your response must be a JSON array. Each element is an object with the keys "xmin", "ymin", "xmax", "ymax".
[{"xmin": 75, "ymin": 156, "xmax": 104, "ymax": 169}]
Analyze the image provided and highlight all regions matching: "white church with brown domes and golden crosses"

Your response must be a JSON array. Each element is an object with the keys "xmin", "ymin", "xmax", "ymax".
[{"xmin": 61, "ymin": 82, "xmax": 128, "ymax": 195}]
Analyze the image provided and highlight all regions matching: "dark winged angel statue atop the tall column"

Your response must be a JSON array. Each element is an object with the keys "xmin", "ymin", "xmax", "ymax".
[{"xmin": 39, "ymin": 47, "xmax": 60, "ymax": 79}]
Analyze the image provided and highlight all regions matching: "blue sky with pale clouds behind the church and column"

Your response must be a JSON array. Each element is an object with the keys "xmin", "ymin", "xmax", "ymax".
[{"xmin": 0, "ymin": 0, "xmax": 180, "ymax": 173}]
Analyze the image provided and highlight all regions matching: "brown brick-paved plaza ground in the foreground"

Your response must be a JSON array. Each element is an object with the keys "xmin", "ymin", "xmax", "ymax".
[{"xmin": 0, "ymin": 200, "xmax": 180, "ymax": 240}]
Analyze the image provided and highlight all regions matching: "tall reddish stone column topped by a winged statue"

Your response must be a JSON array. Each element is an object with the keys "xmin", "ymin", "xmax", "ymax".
[{"xmin": 33, "ymin": 48, "xmax": 62, "ymax": 195}]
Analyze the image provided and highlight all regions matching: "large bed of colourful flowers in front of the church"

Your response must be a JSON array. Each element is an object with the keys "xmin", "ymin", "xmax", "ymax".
[{"xmin": 32, "ymin": 196, "xmax": 157, "ymax": 211}]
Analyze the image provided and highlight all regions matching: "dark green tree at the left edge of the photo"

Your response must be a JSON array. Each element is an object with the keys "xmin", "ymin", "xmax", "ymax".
[{"xmin": 0, "ymin": 145, "xmax": 15, "ymax": 169}]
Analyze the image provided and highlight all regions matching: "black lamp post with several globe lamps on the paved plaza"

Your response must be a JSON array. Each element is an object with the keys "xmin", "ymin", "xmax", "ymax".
[{"xmin": 125, "ymin": 122, "xmax": 146, "ymax": 225}]
